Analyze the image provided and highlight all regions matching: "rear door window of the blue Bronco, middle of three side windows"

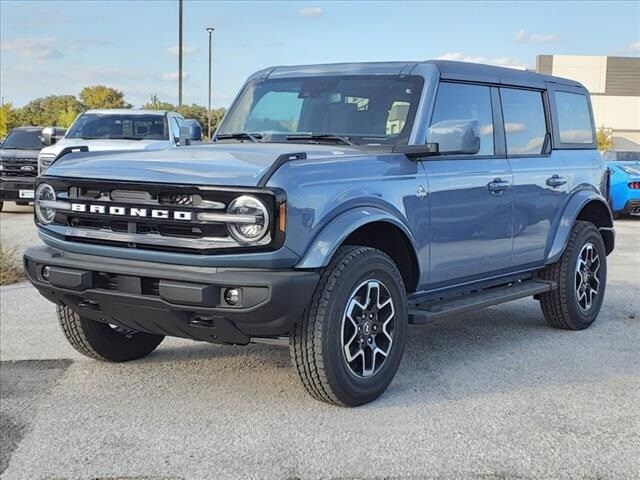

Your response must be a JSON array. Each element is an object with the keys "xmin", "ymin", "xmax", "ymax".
[{"xmin": 500, "ymin": 88, "xmax": 547, "ymax": 155}]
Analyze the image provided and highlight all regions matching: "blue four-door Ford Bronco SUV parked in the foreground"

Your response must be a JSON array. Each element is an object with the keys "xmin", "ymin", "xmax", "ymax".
[{"xmin": 24, "ymin": 61, "xmax": 614, "ymax": 406}]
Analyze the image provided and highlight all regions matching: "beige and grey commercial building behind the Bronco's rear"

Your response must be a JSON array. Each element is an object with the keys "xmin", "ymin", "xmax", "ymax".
[{"xmin": 536, "ymin": 55, "xmax": 640, "ymax": 150}]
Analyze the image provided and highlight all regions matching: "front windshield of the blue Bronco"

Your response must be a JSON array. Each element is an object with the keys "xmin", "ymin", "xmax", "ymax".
[{"xmin": 216, "ymin": 75, "xmax": 423, "ymax": 145}]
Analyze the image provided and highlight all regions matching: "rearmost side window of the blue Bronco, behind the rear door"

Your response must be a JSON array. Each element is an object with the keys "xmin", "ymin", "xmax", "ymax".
[{"xmin": 555, "ymin": 92, "xmax": 593, "ymax": 143}]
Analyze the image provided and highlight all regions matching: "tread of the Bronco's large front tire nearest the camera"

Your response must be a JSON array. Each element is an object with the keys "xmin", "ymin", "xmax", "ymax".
[{"xmin": 289, "ymin": 246, "xmax": 404, "ymax": 406}]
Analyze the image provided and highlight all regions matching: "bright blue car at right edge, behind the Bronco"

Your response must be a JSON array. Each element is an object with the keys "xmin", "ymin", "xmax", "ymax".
[{"xmin": 602, "ymin": 150, "xmax": 640, "ymax": 215}]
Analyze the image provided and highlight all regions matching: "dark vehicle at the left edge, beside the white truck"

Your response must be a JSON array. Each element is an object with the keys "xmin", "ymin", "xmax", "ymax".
[{"xmin": 0, "ymin": 127, "xmax": 50, "ymax": 211}]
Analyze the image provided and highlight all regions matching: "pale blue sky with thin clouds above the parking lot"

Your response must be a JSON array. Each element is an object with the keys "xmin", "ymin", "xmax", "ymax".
[{"xmin": 0, "ymin": 0, "xmax": 640, "ymax": 108}]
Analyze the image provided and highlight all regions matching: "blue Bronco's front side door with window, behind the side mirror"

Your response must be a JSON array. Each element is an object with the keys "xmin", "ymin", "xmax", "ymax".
[{"xmin": 423, "ymin": 82, "xmax": 513, "ymax": 288}]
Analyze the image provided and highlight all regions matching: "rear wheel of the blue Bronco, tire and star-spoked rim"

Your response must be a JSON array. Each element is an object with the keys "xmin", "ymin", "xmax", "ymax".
[{"xmin": 540, "ymin": 222, "xmax": 607, "ymax": 330}]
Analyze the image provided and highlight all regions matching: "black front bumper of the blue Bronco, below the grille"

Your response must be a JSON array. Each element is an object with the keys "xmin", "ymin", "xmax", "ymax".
[{"xmin": 24, "ymin": 246, "xmax": 319, "ymax": 345}]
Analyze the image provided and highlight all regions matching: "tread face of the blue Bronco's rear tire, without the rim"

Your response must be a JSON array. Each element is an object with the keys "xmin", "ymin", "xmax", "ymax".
[{"xmin": 540, "ymin": 221, "xmax": 596, "ymax": 330}]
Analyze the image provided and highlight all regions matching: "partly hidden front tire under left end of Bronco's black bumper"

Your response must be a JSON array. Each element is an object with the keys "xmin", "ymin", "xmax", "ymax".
[{"xmin": 58, "ymin": 306, "xmax": 164, "ymax": 362}]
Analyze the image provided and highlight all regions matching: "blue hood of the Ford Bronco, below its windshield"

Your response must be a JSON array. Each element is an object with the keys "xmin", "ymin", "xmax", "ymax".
[{"xmin": 47, "ymin": 143, "xmax": 360, "ymax": 186}]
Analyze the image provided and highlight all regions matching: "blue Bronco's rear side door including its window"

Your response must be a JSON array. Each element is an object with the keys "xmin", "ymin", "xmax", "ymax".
[{"xmin": 500, "ymin": 87, "xmax": 568, "ymax": 268}]
